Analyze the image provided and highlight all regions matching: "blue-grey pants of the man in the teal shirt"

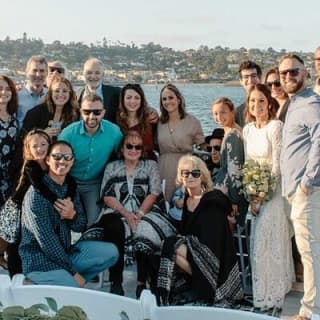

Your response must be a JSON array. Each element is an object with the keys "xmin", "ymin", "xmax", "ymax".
[{"xmin": 77, "ymin": 179, "xmax": 101, "ymax": 227}]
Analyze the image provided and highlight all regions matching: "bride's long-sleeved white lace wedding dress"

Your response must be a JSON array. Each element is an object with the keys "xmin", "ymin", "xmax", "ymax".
[{"xmin": 243, "ymin": 120, "xmax": 294, "ymax": 310}]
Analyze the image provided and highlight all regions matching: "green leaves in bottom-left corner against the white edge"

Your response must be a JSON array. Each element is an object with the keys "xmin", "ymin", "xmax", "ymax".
[{"xmin": 0, "ymin": 297, "xmax": 88, "ymax": 320}]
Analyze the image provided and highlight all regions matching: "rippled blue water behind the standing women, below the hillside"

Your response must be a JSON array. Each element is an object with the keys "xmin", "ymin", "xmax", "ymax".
[{"xmin": 143, "ymin": 84, "xmax": 245, "ymax": 135}]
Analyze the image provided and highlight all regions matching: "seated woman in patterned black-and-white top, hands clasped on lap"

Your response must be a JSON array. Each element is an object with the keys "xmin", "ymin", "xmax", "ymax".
[{"xmin": 94, "ymin": 130, "xmax": 175, "ymax": 296}]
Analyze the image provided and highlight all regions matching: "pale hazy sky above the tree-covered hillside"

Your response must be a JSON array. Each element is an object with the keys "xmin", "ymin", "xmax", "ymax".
[{"xmin": 0, "ymin": 0, "xmax": 320, "ymax": 51}]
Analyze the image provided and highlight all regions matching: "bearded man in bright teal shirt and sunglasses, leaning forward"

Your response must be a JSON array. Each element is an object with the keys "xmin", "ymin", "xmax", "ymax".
[{"xmin": 58, "ymin": 94, "xmax": 122, "ymax": 226}]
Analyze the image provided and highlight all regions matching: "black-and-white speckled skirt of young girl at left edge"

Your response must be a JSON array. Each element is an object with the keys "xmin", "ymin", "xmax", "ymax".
[{"xmin": 0, "ymin": 198, "xmax": 21, "ymax": 243}]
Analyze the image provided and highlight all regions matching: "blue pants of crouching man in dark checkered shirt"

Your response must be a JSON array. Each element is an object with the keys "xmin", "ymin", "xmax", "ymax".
[{"xmin": 27, "ymin": 240, "xmax": 119, "ymax": 287}]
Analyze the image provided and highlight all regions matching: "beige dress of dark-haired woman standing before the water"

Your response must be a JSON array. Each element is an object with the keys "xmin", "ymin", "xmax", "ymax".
[{"xmin": 158, "ymin": 114, "xmax": 204, "ymax": 201}]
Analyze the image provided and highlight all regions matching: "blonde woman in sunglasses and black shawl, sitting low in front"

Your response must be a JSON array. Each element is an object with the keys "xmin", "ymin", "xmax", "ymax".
[{"xmin": 158, "ymin": 155, "xmax": 242, "ymax": 305}]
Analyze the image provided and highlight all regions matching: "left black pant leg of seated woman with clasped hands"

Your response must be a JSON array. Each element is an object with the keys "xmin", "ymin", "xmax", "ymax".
[{"xmin": 93, "ymin": 213, "xmax": 125, "ymax": 283}]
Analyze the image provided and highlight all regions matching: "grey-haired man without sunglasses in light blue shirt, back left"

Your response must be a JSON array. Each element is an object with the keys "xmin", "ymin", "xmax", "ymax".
[{"xmin": 17, "ymin": 55, "xmax": 48, "ymax": 128}]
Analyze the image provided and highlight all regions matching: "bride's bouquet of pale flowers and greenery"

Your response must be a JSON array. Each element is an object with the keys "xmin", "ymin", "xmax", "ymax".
[{"xmin": 242, "ymin": 160, "xmax": 277, "ymax": 208}]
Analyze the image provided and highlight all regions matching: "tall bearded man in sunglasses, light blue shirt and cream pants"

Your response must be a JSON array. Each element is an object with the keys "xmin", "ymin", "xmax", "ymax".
[{"xmin": 279, "ymin": 54, "xmax": 320, "ymax": 320}]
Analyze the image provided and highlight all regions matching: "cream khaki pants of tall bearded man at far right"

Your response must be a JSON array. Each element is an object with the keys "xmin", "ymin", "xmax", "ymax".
[{"xmin": 289, "ymin": 186, "xmax": 320, "ymax": 318}]
